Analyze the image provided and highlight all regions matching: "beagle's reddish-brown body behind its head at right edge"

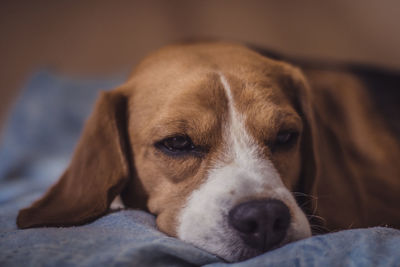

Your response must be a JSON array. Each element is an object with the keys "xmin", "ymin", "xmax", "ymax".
[{"xmin": 306, "ymin": 70, "xmax": 400, "ymax": 230}]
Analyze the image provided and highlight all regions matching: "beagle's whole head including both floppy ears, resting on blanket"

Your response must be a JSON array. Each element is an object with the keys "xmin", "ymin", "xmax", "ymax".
[{"xmin": 17, "ymin": 43, "xmax": 315, "ymax": 261}]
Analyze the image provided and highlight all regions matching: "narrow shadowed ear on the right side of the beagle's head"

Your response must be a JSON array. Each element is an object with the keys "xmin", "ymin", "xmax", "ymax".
[{"xmin": 282, "ymin": 65, "xmax": 321, "ymax": 230}]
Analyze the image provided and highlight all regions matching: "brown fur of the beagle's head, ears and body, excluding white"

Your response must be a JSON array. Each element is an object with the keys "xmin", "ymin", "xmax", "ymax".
[{"xmin": 17, "ymin": 43, "xmax": 400, "ymax": 236}]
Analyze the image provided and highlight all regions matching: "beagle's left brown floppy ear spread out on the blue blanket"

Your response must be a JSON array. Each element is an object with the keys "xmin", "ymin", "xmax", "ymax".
[{"xmin": 17, "ymin": 92, "xmax": 132, "ymax": 228}]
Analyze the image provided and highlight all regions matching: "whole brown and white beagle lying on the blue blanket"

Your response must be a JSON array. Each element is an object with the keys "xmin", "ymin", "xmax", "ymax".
[{"xmin": 17, "ymin": 43, "xmax": 400, "ymax": 262}]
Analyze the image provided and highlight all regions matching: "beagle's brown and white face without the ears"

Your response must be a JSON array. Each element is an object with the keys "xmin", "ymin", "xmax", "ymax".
[{"xmin": 123, "ymin": 44, "xmax": 310, "ymax": 260}]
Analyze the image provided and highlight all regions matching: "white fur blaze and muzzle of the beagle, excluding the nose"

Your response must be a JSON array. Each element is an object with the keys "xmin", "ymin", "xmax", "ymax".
[{"xmin": 177, "ymin": 74, "xmax": 311, "ymax": 261}]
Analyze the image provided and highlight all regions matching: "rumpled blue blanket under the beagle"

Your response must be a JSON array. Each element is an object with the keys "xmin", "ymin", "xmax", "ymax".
[{"xmin": 0, "ymin": 71, "xmax": 400, "ymax": 266}]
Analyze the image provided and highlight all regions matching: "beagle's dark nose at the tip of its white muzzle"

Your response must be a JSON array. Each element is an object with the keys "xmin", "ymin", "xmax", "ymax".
[{"xmin": 229, "ymin": 199, "xmax": 290, "ymax": 251}]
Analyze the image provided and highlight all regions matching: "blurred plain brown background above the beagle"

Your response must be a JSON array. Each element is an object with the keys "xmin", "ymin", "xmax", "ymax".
[{"xmin": 0, "ymin": 0, "xmax": 400, "ymax": 130}]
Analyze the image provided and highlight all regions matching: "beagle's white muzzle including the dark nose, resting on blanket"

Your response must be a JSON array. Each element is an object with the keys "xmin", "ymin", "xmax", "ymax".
[{"xmin": 177, "ymin": 162, "xmax": 311, "ymax": 262}]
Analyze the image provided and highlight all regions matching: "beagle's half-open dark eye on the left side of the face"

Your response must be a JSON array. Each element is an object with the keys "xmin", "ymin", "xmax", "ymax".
[{"xmin": 155, "ymin": 135, "xmax": 196, "ymax": 155}]
